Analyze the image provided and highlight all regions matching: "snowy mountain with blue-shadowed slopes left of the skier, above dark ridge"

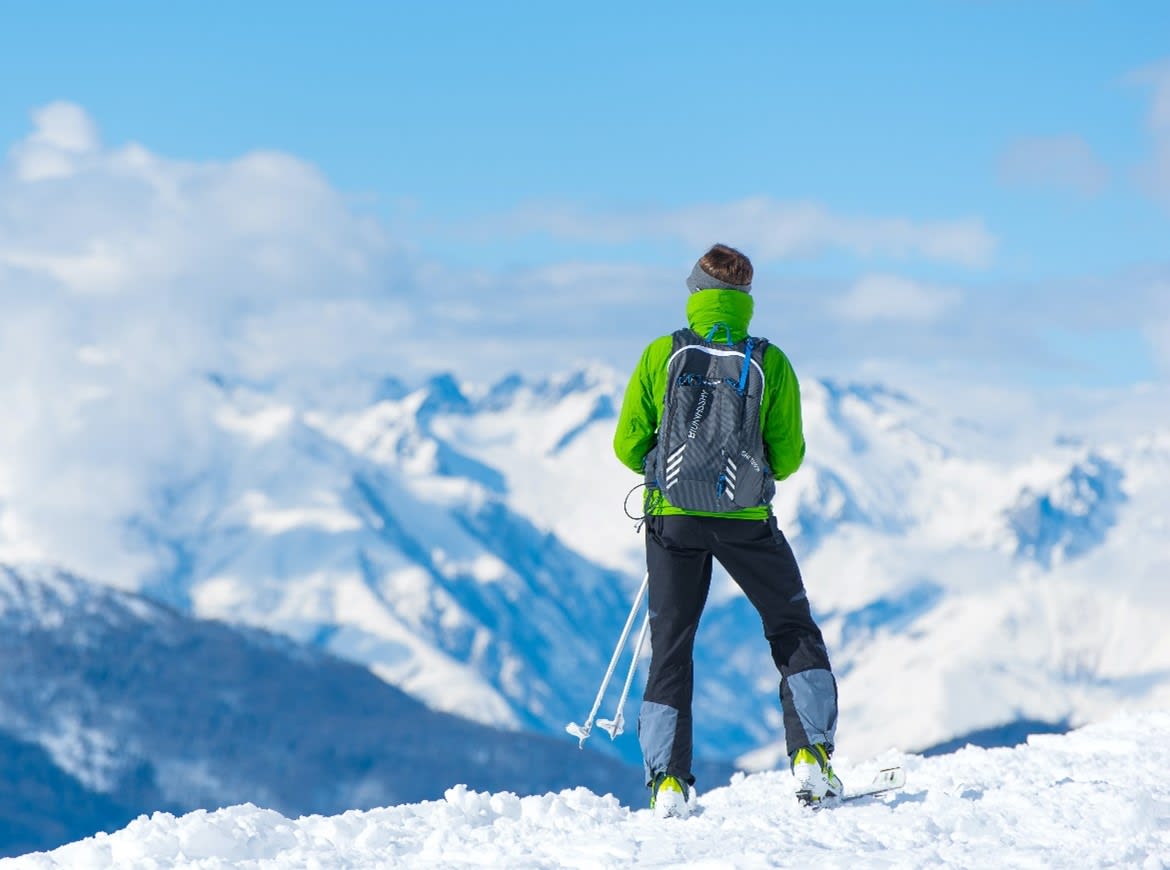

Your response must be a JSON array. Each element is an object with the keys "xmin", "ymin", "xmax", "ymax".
[{"xmin": 123, "ymin": 377, "xmax": 631, "ymax": 753}]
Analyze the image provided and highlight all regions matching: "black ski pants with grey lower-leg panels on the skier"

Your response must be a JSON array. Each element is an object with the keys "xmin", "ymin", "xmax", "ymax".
[{"xmin": 638, "ymin": 516, "xmax": 837, "ymax": 785}]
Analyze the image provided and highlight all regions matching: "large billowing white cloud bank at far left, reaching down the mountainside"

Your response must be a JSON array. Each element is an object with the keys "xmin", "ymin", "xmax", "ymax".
[{"xmin": 0, "ymin": 103, "xmax": 415, "ymax": 578}]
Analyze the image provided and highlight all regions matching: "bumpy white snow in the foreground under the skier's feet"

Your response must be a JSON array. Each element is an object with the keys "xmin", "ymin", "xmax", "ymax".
[{"xmin": 11, "ymin": 712, "xmax": 1170, "ymax": 870}]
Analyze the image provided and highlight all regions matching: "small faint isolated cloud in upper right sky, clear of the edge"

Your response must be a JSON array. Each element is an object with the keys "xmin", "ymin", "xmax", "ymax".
[{"xmin": 999, "ymin": 136, "xmax": 1109, "ymax": 196}]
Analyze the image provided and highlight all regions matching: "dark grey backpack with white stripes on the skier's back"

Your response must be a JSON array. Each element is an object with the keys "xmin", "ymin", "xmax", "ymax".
[{"xmin": 645, "ymin": 326, "xmax": 776, "ymax": 513}]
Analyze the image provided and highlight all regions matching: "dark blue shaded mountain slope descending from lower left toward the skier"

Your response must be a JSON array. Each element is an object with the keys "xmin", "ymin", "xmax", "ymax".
[{"xmin": 0, "ymin": 566, "xmax": 650, "ymax": 855}]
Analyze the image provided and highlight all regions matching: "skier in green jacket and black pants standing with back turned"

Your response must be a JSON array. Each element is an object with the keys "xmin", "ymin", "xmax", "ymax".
[{"xmin": 613, "ymin": 244, "xmax": 842, "ymax": 816}]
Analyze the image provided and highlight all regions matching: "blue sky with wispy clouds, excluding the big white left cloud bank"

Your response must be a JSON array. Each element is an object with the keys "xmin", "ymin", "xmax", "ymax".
[{"xmin": 0, "ymin": 0, "xmax": 1170, "ymax": 388}]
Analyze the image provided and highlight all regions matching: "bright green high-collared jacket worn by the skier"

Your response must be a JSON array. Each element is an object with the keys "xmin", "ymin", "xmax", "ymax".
[{"xmin": 613, "ymin": 290, "xmax": 805, "ymax": 519}]
